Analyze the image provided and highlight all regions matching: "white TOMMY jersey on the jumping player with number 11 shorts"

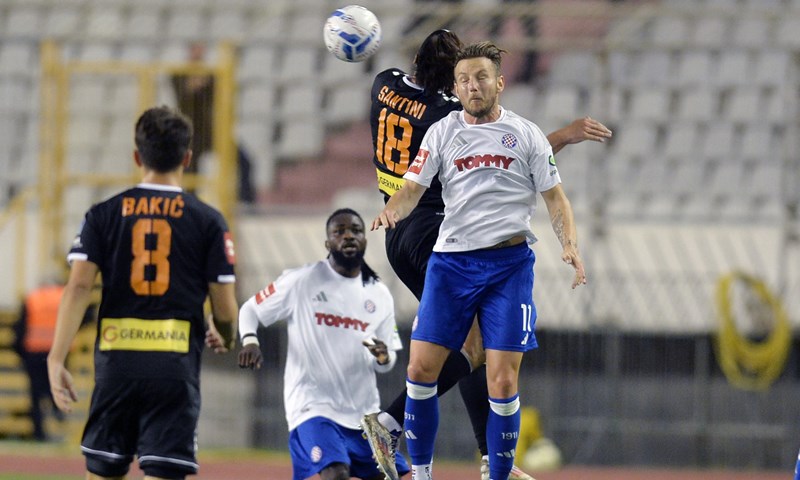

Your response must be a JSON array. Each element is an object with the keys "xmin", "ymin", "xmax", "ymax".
[{"xmin": 404, "ymin": 108, "xmax": 561, "ymax": 252}]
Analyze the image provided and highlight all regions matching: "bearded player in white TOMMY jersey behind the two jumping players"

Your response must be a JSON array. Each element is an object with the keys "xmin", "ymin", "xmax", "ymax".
[{"xmin": 239, "ymin": 209, "xmax": 409, "ymax": 480}]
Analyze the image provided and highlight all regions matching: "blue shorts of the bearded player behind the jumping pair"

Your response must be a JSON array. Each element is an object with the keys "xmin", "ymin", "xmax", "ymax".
[{"xmin": 289, "ymin": 417, "xmax": 411, "ymax": 480}]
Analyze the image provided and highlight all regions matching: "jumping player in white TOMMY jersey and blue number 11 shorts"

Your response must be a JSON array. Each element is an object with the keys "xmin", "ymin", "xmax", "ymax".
[{"xmin": 372, "ymin": 42, "xmax": 586, "ymax": 480}]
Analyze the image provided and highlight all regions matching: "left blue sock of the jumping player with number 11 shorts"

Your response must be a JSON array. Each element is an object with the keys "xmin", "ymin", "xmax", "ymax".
[{"xmin": 403, "ymin": 379, "xmax": 439, "ymax": 465}]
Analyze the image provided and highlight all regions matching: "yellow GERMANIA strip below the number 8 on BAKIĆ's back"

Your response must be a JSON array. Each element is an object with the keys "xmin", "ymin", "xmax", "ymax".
[{"xmin": 100, "ymin": 318, "xmax": 191, "ymax": 353}]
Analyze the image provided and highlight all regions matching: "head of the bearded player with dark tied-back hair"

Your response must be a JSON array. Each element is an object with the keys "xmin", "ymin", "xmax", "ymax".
[{"xmin": 325, "ymin": 208, "xmax": 378, "ymax": 283}]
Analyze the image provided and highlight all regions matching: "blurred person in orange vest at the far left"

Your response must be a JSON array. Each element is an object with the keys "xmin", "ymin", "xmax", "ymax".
[{"xmin": 14, "ymin": 285, "xmax": 64, "ymax": 441}]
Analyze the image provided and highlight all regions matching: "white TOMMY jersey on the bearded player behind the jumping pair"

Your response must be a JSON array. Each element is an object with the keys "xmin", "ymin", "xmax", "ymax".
[{"xmin": 239, "ymin": 260, "xmax": 403, "ymax": 430}]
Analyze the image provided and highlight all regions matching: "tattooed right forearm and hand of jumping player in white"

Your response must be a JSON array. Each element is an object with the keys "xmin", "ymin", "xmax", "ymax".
[{"xmin": 542, "ymin": 184, "xmax": 586, "ymax": 288}]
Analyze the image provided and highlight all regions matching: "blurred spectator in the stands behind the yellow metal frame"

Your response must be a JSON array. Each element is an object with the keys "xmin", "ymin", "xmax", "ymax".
[{"xmin": 172, "ymin": 42, "xmax": 255, "ymax": 203}]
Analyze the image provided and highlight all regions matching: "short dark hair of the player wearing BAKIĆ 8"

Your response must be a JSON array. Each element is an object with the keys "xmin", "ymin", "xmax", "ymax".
[{"xmin": 136, "ymin": 106, "xmax": 192, "ymax": 173}]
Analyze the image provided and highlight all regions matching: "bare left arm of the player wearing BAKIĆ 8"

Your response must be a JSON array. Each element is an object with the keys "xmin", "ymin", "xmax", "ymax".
[{"xmin": 47, "ymin": 260, "xmax": 98, "ymax": 413}]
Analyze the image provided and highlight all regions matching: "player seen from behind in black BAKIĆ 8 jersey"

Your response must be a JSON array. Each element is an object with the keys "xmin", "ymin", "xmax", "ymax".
[{"xmin": 48, "ymin": 107, "xmax": 238, "ymax": 479}]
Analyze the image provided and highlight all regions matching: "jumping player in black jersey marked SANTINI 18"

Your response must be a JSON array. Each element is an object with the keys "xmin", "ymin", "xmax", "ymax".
[{"xmin": 362, "ymin": 30, "xmax": 611, "ymax": 480}]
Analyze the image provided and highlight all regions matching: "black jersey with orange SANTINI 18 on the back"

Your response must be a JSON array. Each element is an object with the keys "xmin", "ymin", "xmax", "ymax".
[{"xmin": 370, "ymin": 69, "xmax": 461, "ymax": 208}]
